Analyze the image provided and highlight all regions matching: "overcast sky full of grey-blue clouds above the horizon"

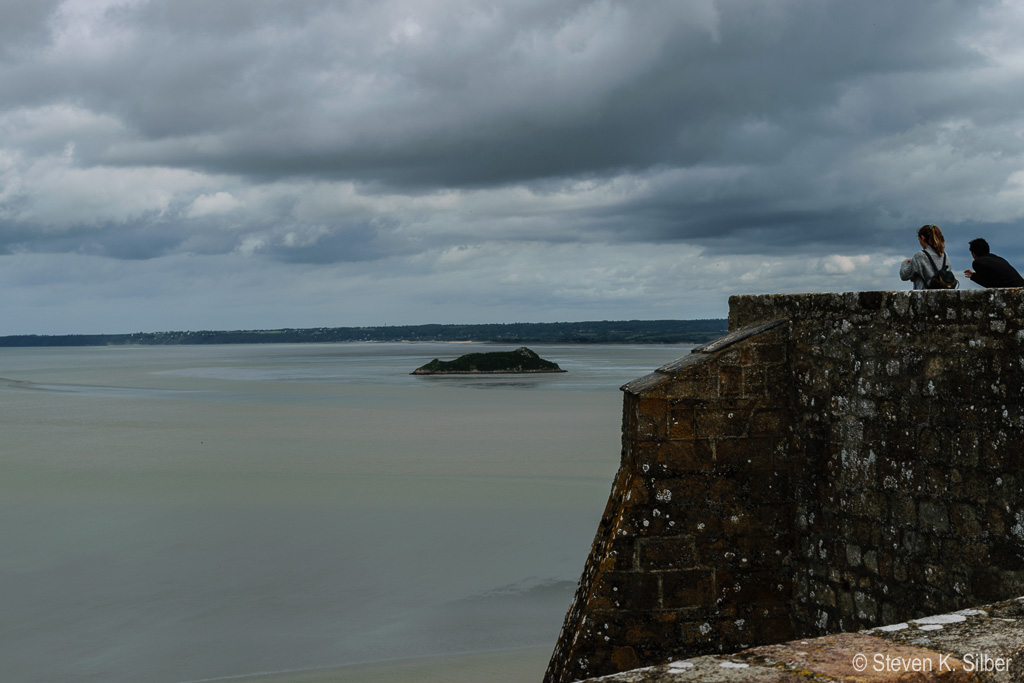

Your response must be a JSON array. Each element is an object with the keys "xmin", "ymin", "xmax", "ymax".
[{"xmin": 0, "ymin": 0, "xmax": 1024, "ymax": 334}]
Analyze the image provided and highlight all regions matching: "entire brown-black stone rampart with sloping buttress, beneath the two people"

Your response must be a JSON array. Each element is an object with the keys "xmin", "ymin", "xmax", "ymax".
[{"xmin": 546, "ymin": 290, "xmax": 1024, "ymax": 682}]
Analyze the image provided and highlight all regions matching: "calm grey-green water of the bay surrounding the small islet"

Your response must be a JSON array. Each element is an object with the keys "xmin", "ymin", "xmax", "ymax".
[{"xmin": 0, "ymin": 344, "xmax": 690, "ymax": 683}]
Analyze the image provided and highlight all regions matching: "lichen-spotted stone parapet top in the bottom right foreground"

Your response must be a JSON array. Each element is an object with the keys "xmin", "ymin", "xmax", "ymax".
[{"xmin": 589, "ymin": 597, "xmax": 1024, "ymax": 683}]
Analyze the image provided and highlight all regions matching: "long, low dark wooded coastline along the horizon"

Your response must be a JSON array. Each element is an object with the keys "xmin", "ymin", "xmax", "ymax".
[{"xmin": 0, "ymin": 318, "xmax": 728, "ymax": 347}]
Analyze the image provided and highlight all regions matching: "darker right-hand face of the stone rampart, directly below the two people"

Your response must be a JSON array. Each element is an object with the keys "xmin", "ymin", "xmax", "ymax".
[{"xmin": 730, "ymin": 290, "xmax": 1024, "ymax": 633}]
